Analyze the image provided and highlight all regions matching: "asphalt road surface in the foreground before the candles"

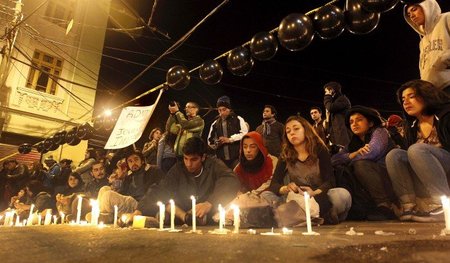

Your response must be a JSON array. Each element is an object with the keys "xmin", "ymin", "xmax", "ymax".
[{"xmin": 0, "ymin": 222, "xmax": 450, "ymax": 263}]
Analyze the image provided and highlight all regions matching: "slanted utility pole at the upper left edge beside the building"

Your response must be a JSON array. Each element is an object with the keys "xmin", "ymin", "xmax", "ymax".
[{"xmin": 0, "ymin": 0, "xmax": 23, "ymax": 89}]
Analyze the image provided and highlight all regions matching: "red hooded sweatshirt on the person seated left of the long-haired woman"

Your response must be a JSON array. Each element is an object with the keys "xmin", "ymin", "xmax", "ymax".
[{"xmin": 235, "ymin": 131, "xmax": 273, "ymax": 191}]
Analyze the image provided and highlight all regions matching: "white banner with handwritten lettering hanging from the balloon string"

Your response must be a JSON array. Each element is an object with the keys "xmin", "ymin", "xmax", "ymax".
[{"xmin": 105, "ymin": 89, "xmax": 163, "ymax": 149}]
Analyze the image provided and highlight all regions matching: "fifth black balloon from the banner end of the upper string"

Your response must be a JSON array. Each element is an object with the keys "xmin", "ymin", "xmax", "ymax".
[{"xmin": 278, "ymin": 13, "xmax": 314, "ymax": 51}]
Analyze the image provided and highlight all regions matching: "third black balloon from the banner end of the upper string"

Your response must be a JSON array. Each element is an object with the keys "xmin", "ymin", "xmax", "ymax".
[{"xmin": 227, "ymin": 46, "xmax": 254, "ymax": 76}]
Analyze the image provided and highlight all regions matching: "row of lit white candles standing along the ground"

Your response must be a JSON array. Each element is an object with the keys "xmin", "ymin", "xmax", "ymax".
[{"xmin": 0, "ymin": 192, "xmax": 450, "ymax": 235}]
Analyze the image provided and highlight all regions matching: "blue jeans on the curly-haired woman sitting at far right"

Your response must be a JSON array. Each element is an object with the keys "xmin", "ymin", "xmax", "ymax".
[{"xmin": 386, "ymin": 143, "xmax": 450, "ymax": 204}]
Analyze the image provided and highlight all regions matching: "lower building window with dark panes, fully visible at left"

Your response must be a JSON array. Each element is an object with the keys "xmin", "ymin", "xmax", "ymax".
[{"xmin": 27, "ymin": 50, "xmax": 62, "ymax": 95}]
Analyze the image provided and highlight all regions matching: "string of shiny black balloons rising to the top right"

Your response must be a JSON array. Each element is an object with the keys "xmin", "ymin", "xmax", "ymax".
[{"xmin": 166, "ymin": 0, "xmax": 423, "ymax": 90}]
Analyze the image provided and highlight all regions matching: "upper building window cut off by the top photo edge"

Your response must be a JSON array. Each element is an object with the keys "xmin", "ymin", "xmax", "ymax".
[{"xmin": 45, "ymin": 0, "xmax": 75, "ymax": 28}]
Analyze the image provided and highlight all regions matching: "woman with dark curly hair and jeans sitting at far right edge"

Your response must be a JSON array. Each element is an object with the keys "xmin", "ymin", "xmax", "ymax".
[{"xmin": 386, "ymin": 80, "xmax": 450, "ymax": 222}]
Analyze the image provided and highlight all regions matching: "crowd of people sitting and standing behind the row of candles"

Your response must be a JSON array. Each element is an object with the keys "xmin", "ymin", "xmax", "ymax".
[{"xmin": 0, "ymin": 80, "xmax": 450, "ymax": 229}]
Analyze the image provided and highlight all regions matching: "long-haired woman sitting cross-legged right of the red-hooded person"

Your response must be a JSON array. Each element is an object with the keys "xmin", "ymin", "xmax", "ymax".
[{"xmin": 261, "ymin": 116, "xmax": 351, "ymax": 224}]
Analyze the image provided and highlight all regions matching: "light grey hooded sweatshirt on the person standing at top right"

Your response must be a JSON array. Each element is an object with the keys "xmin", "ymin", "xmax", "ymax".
[{"xmin": 403, "ymin": 0, "xmax": 450, "ymax": 89}]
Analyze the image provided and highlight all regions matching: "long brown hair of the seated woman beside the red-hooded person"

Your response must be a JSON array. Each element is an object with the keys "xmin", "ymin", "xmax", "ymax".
[{"xmin": 280, "ymin": 116, "xmax": 326, "ymax": 165}]
